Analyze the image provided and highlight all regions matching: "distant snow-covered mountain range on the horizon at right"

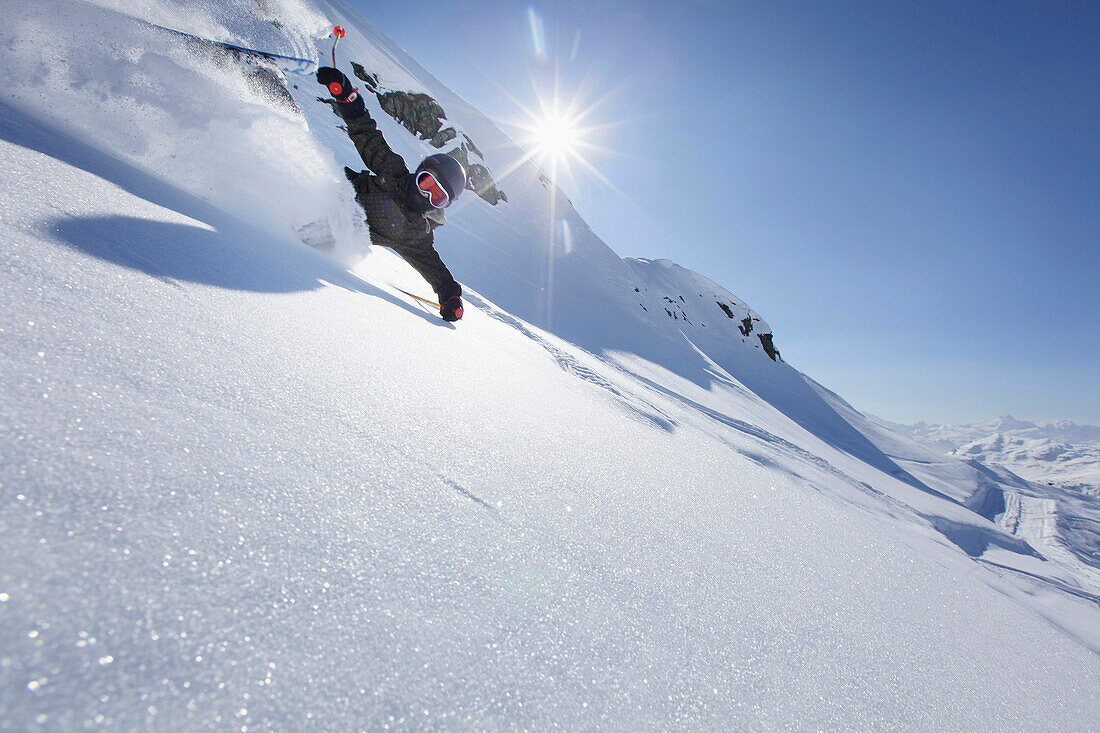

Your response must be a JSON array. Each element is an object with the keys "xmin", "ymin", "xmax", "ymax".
[{"xmin": 878, "ymin": 415, "xmax": 1100, "ymax": 493}]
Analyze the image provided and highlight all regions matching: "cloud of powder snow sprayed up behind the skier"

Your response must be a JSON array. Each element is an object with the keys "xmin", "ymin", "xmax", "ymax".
[{"xmin": 0, "ymin": 0, "xmax": 358, "ymax": 250}]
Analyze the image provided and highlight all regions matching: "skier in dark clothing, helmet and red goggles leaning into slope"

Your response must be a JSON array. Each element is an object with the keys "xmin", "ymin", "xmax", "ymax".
[{"xmin": 317, "ymin": 66, "xmax": 466, "ymax": 321}]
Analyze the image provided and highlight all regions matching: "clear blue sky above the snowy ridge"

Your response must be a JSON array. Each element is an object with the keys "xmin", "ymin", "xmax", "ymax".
[{"xmin": 356, "ymin": 0, "xmax": 1100, "ymax": 424}]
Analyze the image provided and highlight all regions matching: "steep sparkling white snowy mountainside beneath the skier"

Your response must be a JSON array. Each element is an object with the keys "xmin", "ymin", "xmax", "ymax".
[{"xmin": 0, "ymin": 0, "xmax": 1100, "ymax": 730}]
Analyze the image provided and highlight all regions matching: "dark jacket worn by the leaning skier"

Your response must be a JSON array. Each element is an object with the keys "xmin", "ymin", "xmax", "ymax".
[{"xmin": 345, "ymin": 108, "xmax": 462, "ymax": 303}]
